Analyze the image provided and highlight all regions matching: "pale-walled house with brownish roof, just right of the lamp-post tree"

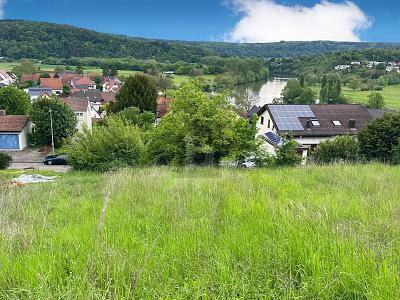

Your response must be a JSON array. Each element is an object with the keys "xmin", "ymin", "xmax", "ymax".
[{"xmin": 60, "ymin": 97, "xmax": 92, "ymax": 131}]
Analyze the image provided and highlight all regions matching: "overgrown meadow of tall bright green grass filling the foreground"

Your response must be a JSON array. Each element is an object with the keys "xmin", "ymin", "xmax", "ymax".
[{"xmin": 0, "ymin": 165, "xmax": 400, "ymax": 299}]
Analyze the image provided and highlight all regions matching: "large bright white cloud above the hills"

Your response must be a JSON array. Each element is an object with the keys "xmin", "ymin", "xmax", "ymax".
[{"xmin": 226, "ymin": 0, "xmax": 372, "ymax": 43}]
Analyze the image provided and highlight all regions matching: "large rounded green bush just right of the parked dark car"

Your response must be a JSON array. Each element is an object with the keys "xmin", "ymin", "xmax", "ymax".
[{"xmin": 68, "ymin": 118, "xmax": 144, "ymax": 172}]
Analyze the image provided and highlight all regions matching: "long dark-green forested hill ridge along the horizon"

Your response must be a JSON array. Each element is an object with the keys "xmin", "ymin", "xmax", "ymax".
[{"xmin": 0, "ymin": 20, "xmax": 400, "ymax": 62}]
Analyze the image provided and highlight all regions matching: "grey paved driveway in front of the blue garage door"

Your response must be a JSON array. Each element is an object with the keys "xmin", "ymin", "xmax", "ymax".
[{"xmin": 8, "ymin": 149, "xmax": 70, "ymax": 173}]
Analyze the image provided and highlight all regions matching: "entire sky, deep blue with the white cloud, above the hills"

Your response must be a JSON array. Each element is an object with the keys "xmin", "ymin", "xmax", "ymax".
[{"xmin": 0, "ymin": 0, "xmax": 400, "ymax": 42}]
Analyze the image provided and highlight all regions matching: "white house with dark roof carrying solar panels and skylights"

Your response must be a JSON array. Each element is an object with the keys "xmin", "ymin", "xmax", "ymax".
[{"xmin": 257, "ymin": 104, "xmax": 373, "ymax": 156}]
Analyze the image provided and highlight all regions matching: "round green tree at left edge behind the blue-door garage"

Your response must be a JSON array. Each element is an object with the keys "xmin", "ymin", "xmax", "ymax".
[{"xmin": 0, "ymin": 86, "xmax": 31, "ymax": 115}]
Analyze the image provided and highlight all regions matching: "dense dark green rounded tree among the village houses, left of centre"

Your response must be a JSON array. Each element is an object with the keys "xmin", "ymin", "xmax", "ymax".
[{"xmin": 110, "ymin": 74, "xmax": 157, "ymax": 113}]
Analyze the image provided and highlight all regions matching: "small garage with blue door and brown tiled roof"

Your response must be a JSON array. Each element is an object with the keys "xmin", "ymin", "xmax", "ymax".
[{"xmin": 0, "ymin": 110, "xmax": 32, "ymax": 151}]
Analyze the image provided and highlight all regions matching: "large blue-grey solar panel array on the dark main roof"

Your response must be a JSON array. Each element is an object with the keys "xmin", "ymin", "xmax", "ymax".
[{"xmin": 269, "ymin": 105, "xmax": 315, "ymax": 131}]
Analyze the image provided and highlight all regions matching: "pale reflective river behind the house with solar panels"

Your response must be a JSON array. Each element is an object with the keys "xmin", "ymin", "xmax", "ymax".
[{"xmin": 235, "ymin": 77, "xmax": 289, "ymax": 106}]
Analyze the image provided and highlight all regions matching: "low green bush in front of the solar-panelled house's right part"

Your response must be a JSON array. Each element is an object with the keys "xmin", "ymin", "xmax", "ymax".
[{"xmin": 314, "ymin": 135, "xmax": 359, "ymax": 164}]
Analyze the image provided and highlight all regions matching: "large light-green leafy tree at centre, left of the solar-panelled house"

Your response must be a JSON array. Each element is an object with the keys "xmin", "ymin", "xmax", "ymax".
[{"xmin": 147, "ymin": 80, "xmax": 257, "ymax": 165}]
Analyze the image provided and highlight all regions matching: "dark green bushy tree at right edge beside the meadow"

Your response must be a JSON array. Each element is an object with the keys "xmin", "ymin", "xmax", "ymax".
[{"xmin": 358, "ymin": 113, "xmax": 400, "ymax": 162}]
